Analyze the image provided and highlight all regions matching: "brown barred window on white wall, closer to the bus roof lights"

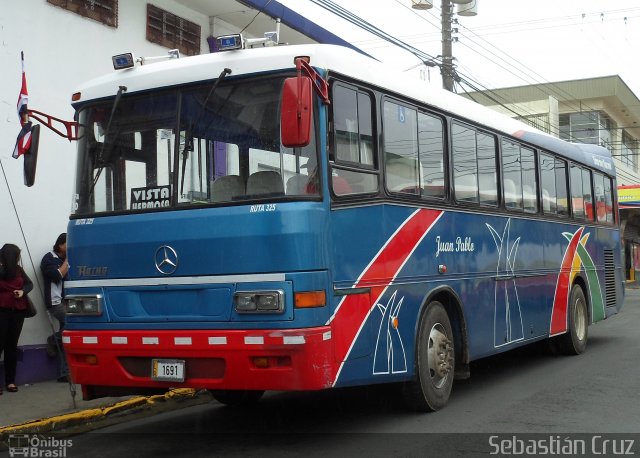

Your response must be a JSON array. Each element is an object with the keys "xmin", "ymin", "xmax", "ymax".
[{"xmin": 147, "ymin": 3, "xmax": 200, "ymax": 56}]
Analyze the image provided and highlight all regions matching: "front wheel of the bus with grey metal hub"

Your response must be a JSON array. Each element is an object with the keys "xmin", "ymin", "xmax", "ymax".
[{"xmin": 403, "ymin": 301, "xmax": 455, "ymax": 412}]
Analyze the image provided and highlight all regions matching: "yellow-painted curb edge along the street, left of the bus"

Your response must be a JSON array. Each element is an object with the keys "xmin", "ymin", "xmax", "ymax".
[{"xmin": 0, "ymin": 388, "xmax": 213, "ymax": 443}]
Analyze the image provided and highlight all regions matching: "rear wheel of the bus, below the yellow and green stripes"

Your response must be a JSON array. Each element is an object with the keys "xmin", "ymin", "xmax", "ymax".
[{"xmin": 555, "ymin": 285, "xmax": 589, "ymax": 355}]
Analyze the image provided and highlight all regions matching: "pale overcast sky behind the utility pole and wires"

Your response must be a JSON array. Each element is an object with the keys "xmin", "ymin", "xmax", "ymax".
[{"xmin": 280, "ymin": 0, "xmax": 640, "ymax": 97}]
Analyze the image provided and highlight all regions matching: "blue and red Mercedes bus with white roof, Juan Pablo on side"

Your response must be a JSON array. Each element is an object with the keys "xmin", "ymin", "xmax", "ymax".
[{"xmin": 57, "ymin": 40, "xmax": 624, "ymax": 411}]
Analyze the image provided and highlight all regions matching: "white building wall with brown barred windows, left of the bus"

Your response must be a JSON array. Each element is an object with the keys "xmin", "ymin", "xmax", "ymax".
[{"xmin": 0, "ymin": 0, "xmax": 238, "ymax": 383}]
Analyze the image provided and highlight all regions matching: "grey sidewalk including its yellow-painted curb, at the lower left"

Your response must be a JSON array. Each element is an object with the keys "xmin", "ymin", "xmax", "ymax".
[{"xmin": 0, "ymin": 380, "xmax": 212, "ymax": 438}]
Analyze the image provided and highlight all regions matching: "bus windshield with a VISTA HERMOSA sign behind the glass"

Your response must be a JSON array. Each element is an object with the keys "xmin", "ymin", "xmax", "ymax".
[{"xmin": 72, "ymin": 77, "xmax": 319, "ymax": 216}]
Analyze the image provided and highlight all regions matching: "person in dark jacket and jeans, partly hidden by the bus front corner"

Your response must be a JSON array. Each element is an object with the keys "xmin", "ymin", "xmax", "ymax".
[{"xmin": 40, "ymin": 232, "xmax": 69, "ymax": 382}]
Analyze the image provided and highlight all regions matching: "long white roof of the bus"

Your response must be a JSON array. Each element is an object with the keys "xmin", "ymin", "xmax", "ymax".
[{"xmin": 75, "ymin": 44, "xmax": 615, "ymax": 175}]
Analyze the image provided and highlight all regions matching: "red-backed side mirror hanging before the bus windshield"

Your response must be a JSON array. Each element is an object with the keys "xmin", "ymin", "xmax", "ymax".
[{"xmin": 280, "ymin": 75, "xmax": 313, "ymax": 148}]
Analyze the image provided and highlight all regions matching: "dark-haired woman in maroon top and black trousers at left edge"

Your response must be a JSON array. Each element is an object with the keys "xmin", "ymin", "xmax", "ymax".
[{"xmin": 0, "ymin": 243, "xmax": 33, "ymax": 395}]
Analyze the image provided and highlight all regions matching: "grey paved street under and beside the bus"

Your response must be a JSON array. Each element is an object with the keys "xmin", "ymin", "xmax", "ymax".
[{"xmin": 28, "ymin": 290, "xmax": 640, "ymax": 457}]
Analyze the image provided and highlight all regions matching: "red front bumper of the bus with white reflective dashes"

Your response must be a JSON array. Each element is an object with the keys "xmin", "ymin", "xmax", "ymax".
[{"xmin": 63, "ymin": 326, "xmax": 339, "ymax": 390}]
